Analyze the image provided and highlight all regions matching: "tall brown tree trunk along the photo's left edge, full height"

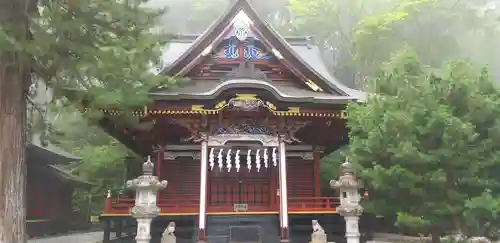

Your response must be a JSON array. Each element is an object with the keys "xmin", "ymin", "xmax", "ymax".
[{"xmin": 0, "ymin": 0, "xmax": 29, "ymax": 243}]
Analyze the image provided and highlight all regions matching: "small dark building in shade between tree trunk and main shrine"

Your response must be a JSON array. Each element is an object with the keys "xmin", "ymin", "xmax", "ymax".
[{"xmin": 26, "ymin": 140, "xmax": 91, "ymax": 237}]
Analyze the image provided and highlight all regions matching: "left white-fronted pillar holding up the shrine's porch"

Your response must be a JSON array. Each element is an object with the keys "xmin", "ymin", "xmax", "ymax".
[{"xmin": 198, "ymin": 134, "xmax": 208, "ymax": 242}]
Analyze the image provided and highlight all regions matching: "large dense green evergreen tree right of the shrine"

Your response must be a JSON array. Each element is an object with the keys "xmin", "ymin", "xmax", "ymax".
[{"xmin": 347, "ymin": 51, "xmax": 500, "ymax": 237}]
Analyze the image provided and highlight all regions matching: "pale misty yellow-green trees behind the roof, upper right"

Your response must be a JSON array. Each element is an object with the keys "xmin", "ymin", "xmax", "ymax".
[{"xmin": 289, "ymin": 0, "xmax": 500, "ymax": 86}]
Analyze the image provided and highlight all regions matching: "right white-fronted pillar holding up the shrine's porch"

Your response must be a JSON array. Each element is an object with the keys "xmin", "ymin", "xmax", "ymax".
[{"xmin": 279, "ymin": 136, "xmax": 290, "ymax": 242}]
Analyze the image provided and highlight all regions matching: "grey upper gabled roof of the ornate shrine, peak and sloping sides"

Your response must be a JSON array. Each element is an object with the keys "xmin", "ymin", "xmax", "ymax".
[{"xmin": 157, "ymin": 0, "xmax": 366, "ymax": 100}]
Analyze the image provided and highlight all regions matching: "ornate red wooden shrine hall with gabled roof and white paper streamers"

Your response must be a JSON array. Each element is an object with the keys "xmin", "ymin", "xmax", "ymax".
[{"xmin": 93, "ymin": 0, "xmax": 365, "ymax": 243}]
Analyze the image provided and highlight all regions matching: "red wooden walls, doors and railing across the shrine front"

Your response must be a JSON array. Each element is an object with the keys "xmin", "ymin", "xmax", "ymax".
[{"xmin": 105, "ymin": 158, "xmax": 339, "ymax": 214}]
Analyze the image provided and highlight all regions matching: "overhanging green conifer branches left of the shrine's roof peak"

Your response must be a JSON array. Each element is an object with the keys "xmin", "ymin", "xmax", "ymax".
[{"xmin": 0, "ymin": 0, "xmax": 175, "ymax": 112}]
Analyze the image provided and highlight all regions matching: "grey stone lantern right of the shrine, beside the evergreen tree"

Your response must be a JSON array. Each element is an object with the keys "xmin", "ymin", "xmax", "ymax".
[{"xmin": 330, "ymin": 159, "xmax": 363, "ymax": 243}]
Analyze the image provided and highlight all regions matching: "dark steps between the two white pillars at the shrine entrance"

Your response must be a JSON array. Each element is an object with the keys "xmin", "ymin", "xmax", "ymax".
[{"xmin": 207, "ymin": 215, "xmax": 280, "ymax": 243}]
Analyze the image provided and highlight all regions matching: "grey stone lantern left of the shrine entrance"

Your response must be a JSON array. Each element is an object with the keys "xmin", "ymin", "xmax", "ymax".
[{"xmin": 127, "ymin": 156, "xmax": 167, "ymax": 243}]
